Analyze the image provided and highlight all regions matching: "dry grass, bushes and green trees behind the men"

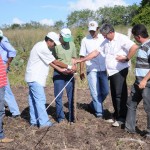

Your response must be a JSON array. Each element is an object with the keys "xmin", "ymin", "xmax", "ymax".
[{"xmin": 2, "ymin": 0, "xmax": 150, "ymax": 88}]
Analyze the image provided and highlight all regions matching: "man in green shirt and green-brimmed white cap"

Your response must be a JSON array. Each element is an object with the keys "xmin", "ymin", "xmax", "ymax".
[{"xmin": 53, "ymin": 28, "xmax": 77, "ymax": 123}]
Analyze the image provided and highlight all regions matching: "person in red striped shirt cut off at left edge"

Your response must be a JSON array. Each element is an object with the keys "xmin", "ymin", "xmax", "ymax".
[{"xmin": 0, "ymin": 55, "xmax": 13, "ymax": 143}]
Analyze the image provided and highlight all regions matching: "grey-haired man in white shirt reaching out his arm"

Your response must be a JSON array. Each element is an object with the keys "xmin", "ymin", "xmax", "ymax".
[{"xmin": 76, "ymin": 24, "xmax": 138, "ymax": 127}]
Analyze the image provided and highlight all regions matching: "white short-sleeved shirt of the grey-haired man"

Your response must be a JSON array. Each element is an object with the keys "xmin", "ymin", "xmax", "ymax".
[{"xmin": 99, "ymin": 32, "xmax": 135, "ymax": 76}]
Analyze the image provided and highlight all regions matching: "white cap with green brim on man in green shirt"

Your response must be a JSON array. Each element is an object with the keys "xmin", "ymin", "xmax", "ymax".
[{"xmin": 60, "ymin": 28, "xmax": 72, "ymax": 42}]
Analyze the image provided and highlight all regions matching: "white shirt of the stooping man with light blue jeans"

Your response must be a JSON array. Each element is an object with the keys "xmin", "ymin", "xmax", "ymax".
[{"xmin": 25, "ymin": 41, "xmax": 55, "ymax": 86}]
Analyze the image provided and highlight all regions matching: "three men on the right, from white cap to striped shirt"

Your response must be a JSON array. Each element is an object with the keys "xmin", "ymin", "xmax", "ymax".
[{"xmin": 75, "ymin": 21, "xmax": 150, "ymax": 137}]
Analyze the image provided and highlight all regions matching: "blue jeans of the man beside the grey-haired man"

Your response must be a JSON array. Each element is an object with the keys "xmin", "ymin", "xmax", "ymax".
[{"xmin": 87, "ymin": 71, "xmax": 109, "ymax": 117}]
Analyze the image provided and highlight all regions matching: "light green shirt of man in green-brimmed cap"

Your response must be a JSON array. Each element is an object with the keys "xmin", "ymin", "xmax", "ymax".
[{"xmin": 52, "ymin": 41, "xmax": 77, "ymax": 65}]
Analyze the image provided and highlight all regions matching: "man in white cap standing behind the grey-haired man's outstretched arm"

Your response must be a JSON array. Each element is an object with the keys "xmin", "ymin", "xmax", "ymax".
[{"xmin": 79, "ymin": 21, "xmax": 109, "ymax": 118}]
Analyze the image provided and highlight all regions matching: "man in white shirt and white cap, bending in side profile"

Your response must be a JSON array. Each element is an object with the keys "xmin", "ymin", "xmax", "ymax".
[{"xmin": 25, "ymin": 32, "xmax": 72, "ymax": 127}]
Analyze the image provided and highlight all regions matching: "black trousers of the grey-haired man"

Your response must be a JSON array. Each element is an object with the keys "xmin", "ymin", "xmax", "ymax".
[{"xmin": 109, "ymin": 68, "xmax": 128, "ymax": 120}]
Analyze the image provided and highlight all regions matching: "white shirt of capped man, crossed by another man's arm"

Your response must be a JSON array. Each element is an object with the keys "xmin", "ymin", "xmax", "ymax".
[{"xmin": 79, "ymin": 34, "xmax": 106, "ymax": 72}]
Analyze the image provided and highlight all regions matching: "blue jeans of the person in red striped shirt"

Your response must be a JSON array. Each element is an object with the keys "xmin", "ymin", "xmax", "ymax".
[{"xmin": 0, "ymin": 87, "xmax": 5, "ymax": 139}]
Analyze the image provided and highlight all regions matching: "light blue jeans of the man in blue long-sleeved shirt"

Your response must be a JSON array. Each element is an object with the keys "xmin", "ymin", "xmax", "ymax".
[{"xmin": 5, "ymin": 77, "xmax": 20, "ymax": 116}]
